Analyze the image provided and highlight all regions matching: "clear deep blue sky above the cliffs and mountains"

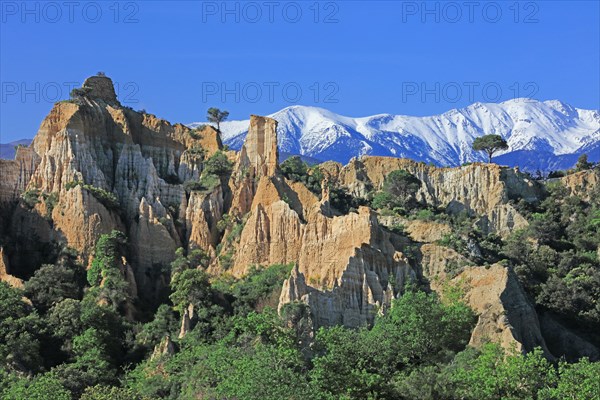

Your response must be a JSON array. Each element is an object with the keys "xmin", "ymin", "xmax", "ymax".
[{"xmin": 0, "ymin": 0, "xmax": 600, "ymax": 142}]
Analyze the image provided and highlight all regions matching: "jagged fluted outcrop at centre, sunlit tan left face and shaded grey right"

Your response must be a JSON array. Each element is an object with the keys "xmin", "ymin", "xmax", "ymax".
[{"xmin": 280, "ymin": 207, "xmax": 416, "ymax": 326}]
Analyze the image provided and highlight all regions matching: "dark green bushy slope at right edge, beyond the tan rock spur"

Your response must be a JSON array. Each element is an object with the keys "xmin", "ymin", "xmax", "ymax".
[{"xmin": 501, "ymin": 183, "xmax": 600, "ymax": 344}]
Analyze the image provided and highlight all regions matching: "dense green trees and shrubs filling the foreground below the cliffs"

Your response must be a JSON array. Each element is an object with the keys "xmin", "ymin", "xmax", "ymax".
[{"xmin": 0, "ymin": 250, "xmax": 600, "ymax": 400}]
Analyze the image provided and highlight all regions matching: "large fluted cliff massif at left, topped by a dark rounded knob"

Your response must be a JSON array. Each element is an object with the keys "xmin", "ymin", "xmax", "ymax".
[{"xmin": 0, "ymin": 76, "xmax": 222, "ymax": 297}]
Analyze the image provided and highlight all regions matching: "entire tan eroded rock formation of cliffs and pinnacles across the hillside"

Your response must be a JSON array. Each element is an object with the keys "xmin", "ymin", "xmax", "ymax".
[{"xmin": 0, "ymin": 76, "xmax": 598, "ymax": 360}]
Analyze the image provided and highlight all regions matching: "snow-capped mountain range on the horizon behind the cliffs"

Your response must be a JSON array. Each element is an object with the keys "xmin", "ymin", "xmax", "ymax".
[{"xmin": 190, "ymin": 98, "xmax": 600, "ymax": 171}]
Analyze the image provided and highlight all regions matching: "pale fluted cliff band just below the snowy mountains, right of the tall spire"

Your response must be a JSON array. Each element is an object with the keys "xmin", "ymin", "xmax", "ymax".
[{"xmin": 326, "ymin": 157, "xmax": 542, "ymax": 235}]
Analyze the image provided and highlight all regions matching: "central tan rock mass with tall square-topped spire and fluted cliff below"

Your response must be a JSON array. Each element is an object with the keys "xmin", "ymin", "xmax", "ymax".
[{"xmin": 219, "ymin": 116, "xmax": 414, "ymax": 326}]
